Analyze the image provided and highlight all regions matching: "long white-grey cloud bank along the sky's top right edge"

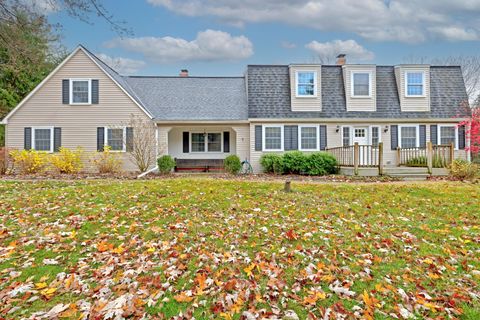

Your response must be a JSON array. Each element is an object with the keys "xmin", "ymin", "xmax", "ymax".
[{"xmin": 147, "ymin": 0, "xmax": 480, "ymax": 42}]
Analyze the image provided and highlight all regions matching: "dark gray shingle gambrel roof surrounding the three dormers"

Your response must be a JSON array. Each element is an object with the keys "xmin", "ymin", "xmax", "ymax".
[{"xmin": 247, "ymin": 65, "xmax": 468, "ymax": 119}]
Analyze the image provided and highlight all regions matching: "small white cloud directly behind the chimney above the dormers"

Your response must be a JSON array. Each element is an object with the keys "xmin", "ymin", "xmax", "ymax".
[{"xmin": 305, "ymin": 40, "xmax": 375, "ymax": 62}]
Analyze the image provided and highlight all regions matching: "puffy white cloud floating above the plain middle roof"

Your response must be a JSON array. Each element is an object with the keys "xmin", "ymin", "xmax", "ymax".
[{"xmin": 106, "ymin": 30, "xmax": 253, "ymax": 63}]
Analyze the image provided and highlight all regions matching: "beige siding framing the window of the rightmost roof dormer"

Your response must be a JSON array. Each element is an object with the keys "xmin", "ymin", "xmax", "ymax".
[{"xmin": 395, "ymin": 65, "xmax": 430, "ymax": 112}]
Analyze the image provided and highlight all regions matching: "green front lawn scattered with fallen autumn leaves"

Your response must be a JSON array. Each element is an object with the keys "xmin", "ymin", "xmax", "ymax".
[{"xmin": 0, "ymin": 179, "xmax": 480, "ymax": 319}]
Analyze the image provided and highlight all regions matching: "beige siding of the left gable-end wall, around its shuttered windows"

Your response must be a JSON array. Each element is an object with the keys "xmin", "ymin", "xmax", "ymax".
[{"xmin": 7, "ymin": 50, "xmax": 148, "ymax": 171}]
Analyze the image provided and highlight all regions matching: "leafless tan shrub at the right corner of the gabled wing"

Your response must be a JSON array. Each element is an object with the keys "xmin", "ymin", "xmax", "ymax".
[{"xmin": 122, "ymin": 115, "xmax": 157, "ymax": 173}]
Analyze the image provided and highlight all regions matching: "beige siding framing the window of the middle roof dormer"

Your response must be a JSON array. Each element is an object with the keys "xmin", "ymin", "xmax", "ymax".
[{"xmin": 342, "ymin": 65, "xmax": 377, "ymax": 111}]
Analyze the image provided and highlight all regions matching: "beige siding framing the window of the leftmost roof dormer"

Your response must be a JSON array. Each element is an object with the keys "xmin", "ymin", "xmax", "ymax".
[{"xmin": 290, "ymin": 65, "xmax": 322, "ymax": 111}]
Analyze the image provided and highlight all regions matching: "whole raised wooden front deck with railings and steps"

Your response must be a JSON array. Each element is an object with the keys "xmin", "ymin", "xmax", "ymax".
[{"xmin": 326, "ymin": 142, "xmax": 455, "ymax": 179}]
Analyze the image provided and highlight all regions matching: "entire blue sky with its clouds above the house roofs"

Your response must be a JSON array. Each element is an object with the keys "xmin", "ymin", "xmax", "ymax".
[{"xmin": 49, "ymin": 0, "xmax": 480, "ymax": 75}]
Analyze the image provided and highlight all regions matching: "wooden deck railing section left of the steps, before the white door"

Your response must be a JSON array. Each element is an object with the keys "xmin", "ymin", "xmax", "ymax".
[{"xmin": 326, "ymin": 142, "xmax": 383, "ymax": 174}]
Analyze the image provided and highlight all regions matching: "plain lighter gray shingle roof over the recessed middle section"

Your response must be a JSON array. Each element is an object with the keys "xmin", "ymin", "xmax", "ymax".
[{"xmin": 125, "ymin": 77, "xmax": 248, "ymax": 120}]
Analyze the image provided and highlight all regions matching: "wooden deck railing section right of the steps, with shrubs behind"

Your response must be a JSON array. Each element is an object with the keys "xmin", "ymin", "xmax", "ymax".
[{"xmin": 397, "ymin": 142, "xmax": 455, "ymax": 171}]
